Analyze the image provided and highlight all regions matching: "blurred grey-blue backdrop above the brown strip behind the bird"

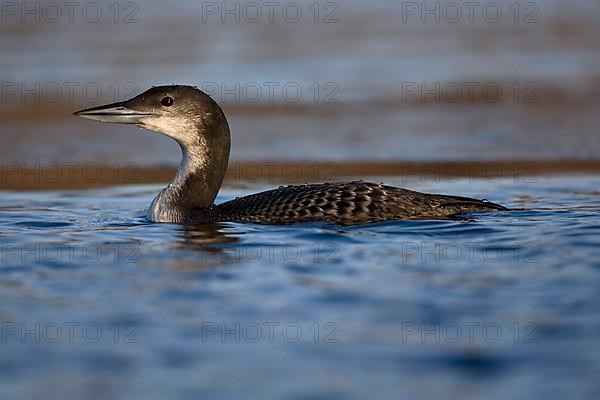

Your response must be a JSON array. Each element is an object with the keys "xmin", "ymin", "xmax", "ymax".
[{"xmin": 0, "ymin": 0, "xmax": 600, "ymax": 186}]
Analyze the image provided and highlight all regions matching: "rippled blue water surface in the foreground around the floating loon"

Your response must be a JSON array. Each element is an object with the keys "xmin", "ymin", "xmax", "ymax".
[{"xmin": 0, "ymin": 176, "xmax": 600, "ymax": 399}]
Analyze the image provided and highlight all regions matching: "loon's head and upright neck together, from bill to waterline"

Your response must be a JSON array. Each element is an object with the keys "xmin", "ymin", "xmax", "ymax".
[{"xmin": 74, "ymin": 85, "xmax": 231, "ymax": 216}]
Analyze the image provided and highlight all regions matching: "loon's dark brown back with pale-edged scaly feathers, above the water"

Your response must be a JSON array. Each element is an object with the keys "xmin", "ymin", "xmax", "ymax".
[{"xmin": 198, "ymin": 182, "xmax": 506, "ymax": 225}]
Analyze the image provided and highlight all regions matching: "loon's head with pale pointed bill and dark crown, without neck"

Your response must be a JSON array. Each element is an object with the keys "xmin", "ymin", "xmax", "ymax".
[{"xmin": 73, "ymin": 85, "xmax": 229, "ymax": 147}]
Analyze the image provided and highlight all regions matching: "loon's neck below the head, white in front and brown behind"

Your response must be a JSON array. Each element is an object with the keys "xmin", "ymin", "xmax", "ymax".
[{"xmin": 147, "ymin": 125, "xmax": 230, "ymax": 223}]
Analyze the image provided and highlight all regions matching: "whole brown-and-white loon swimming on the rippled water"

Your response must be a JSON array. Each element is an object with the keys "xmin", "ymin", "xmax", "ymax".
[{"xmin": 74, "ymin": 85, "xmax": 507, "ymax": 225}]
